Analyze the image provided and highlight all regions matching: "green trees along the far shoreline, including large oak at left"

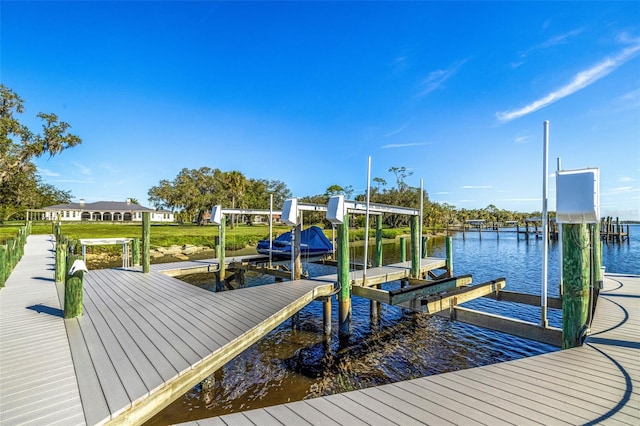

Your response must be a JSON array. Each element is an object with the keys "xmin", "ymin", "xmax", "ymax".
[{"xmin": 0, "ymin": 85, "xmax": 540, "ymax": 228}]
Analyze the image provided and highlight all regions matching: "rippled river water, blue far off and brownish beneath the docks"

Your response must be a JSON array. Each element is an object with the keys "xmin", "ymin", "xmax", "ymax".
[{"xmin": 149, "ymin": 225, "xmax": 640, "ymax": 424}]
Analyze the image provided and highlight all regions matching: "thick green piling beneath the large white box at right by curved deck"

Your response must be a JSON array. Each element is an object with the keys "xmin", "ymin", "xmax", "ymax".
[{"xmin": 562, "ymin": 223, "xmax": 590, "ymax": 349}]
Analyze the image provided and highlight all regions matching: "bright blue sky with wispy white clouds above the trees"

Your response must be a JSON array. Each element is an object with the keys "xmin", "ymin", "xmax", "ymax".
[{"xmin": 0, "ymin": 1, "xmax": 640, "ymax": 219}]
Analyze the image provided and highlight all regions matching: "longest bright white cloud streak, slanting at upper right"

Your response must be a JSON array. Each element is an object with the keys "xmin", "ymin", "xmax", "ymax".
[{"xmin": 496, "ymin": 40, "xmax": 640, "ymax": 121}]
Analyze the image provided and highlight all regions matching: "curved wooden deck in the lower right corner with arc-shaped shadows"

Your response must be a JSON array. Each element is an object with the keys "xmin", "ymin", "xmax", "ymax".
[{"xmin": 189, "ymin": 274, "xmax": 640, "ymax": 426}]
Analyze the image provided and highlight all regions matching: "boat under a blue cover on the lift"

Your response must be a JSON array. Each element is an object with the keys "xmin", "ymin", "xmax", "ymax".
[{"xmin": 257, "ymin": 226, "xmax": 333, "ymax": 259}]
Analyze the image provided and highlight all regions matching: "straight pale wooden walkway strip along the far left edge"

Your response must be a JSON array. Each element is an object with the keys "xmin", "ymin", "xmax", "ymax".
[{"xmin": 0, "ymin": 236, "xmax": 85, "ymax": 425}]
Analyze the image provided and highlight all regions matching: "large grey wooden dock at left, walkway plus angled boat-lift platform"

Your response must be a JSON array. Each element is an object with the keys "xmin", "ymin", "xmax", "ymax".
[{"xmin": 0, "ymin": 235, "xmax": 444, "ymax": 425}]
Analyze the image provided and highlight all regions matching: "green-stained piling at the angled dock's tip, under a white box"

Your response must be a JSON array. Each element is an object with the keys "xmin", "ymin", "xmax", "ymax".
[{"xmin": 337, "ymin": 214, "xmax": 351, "ymax": 337}]
